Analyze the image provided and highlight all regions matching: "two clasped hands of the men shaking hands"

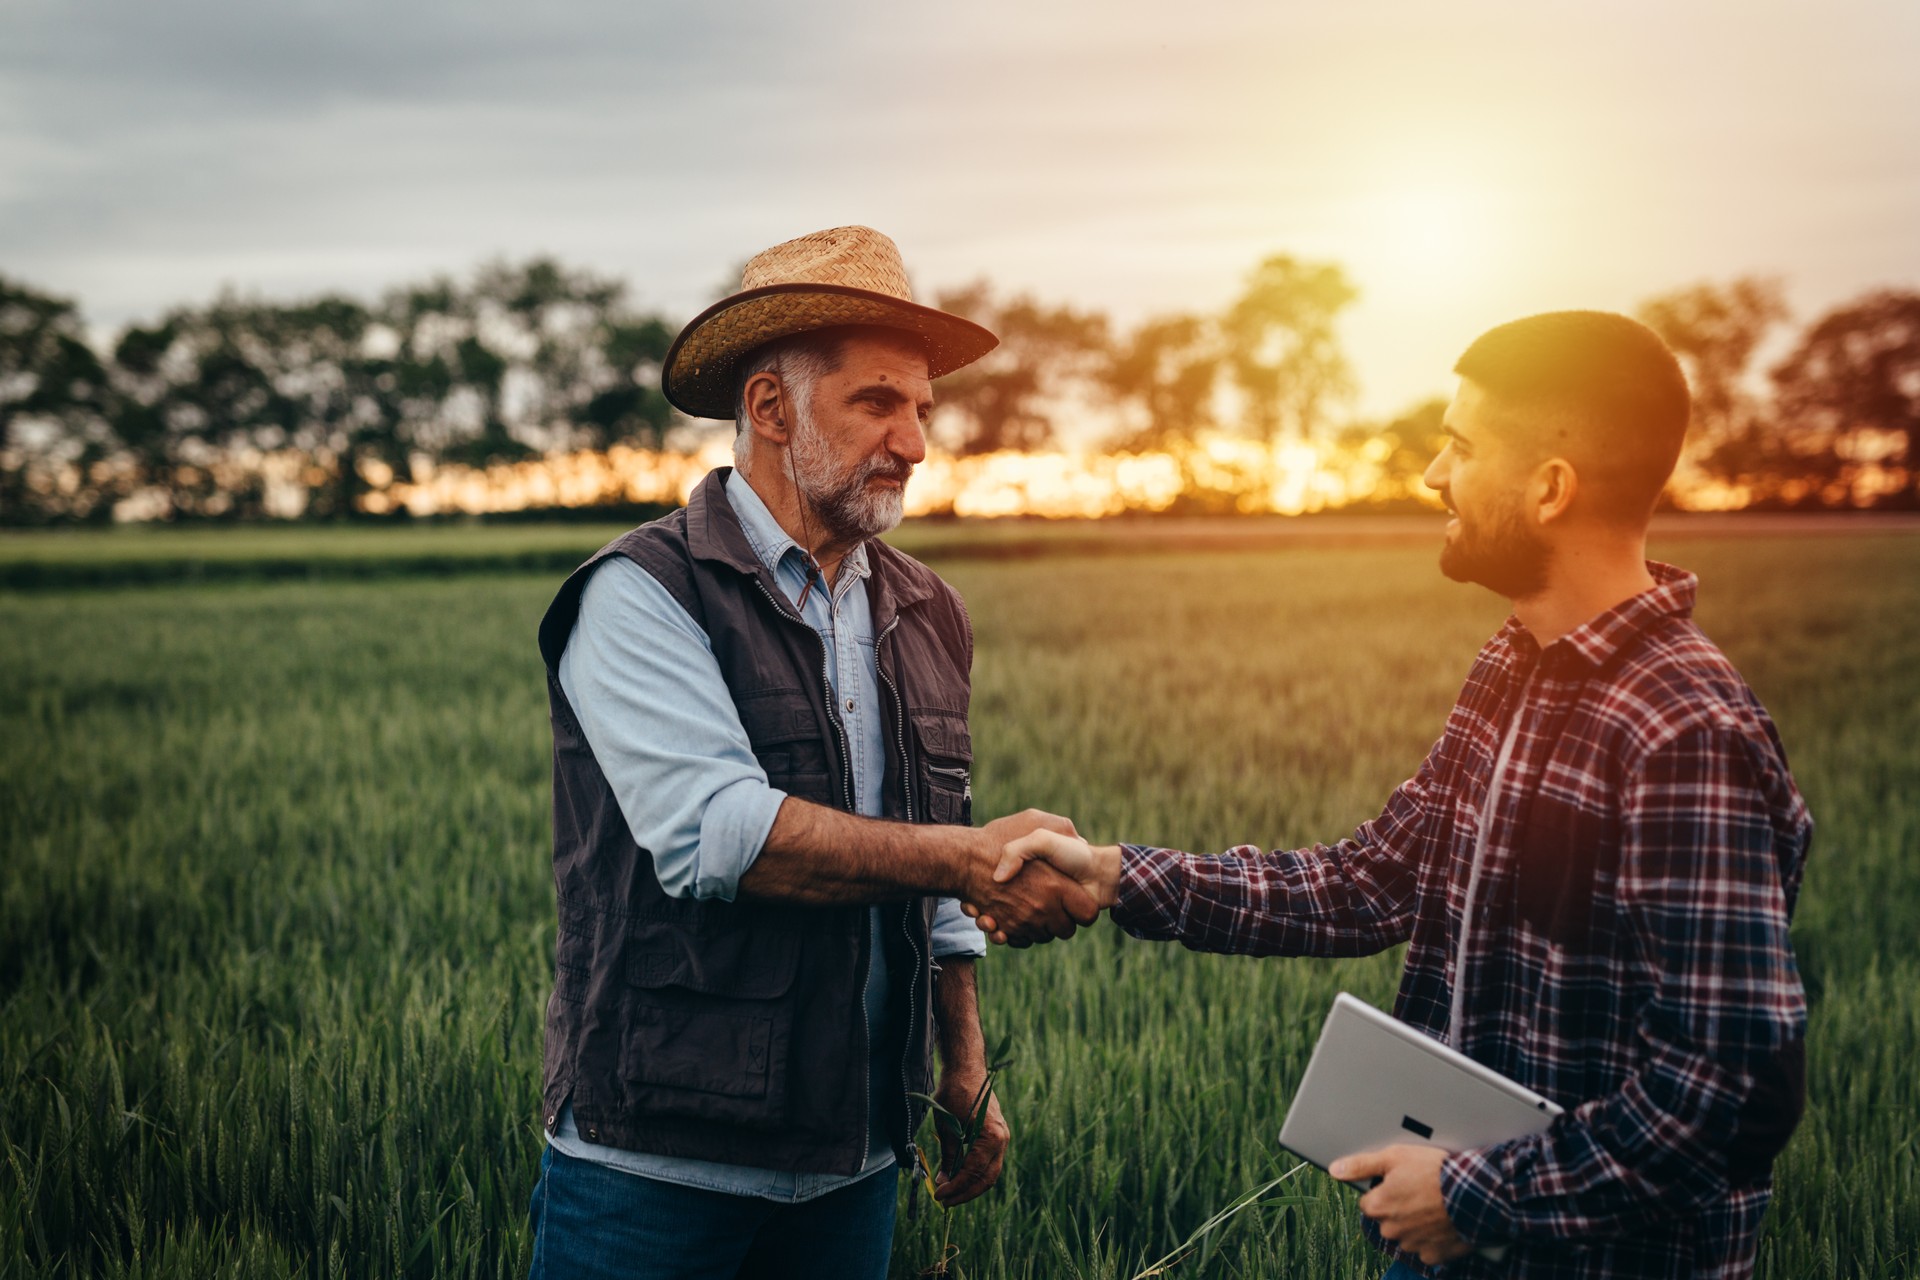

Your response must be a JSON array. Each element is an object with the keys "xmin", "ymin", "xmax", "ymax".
[{"xmin": 956, "ymin": 810, "xmax": 1119, "ymax": 946}]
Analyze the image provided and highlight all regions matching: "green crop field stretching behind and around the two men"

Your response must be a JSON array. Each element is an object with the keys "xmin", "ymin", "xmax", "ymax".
[{"xmin": 0, "ymin": 528, "xmax": 1920, "ymax": 1280}]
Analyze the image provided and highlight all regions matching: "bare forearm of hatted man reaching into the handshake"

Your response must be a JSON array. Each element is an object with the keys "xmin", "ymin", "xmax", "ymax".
[{"xmin": 739, "ymin": 796, "xmax": 998, "ymax": 906}]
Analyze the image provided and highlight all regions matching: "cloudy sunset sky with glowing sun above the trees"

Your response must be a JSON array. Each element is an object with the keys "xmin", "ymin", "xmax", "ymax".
[{"xmin": 0, "ymin": 0, "xmax": 1920, "ymax": 413}]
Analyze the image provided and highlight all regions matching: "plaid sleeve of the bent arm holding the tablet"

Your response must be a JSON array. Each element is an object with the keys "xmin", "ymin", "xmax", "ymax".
[{"xmin": 1440, "ymin": 729, "xmax": 1807, "ymax": 1242}]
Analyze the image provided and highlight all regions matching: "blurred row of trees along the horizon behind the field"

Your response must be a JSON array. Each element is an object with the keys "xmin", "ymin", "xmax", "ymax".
[{"xmin": 0, "ymin": 255, "xmax": 1920, "ymax": 526}]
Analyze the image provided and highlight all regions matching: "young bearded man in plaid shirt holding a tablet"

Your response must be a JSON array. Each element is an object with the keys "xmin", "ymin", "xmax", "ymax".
[{"xmin": 968, "ymin": 311, "xmax": 1811, "ymax": 1278}]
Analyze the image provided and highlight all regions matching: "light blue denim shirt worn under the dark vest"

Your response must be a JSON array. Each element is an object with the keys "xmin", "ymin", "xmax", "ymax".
[{"xmin": 551, "ymin": 472, "xmax": 987, "ymax": 1201}]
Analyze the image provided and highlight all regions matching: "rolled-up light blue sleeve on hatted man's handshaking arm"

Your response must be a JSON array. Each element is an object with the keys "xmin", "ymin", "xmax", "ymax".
[{"xmin": 559, "ymin": 557, "xmax": 787, "ymax": 901}]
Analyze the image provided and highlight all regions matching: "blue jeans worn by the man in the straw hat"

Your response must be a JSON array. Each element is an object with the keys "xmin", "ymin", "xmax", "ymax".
[{"xmin": 528, "ymin": 1148, "xmax": 895, "ymax": 1280}]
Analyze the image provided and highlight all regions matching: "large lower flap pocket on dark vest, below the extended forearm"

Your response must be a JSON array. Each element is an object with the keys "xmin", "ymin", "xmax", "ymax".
[{"xmin": 620, "ymin": 925, "xmax": 799, "ymax": 1128}]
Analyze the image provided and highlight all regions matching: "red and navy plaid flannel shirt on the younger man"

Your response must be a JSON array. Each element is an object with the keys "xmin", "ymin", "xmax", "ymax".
[{"xmin": 1114, "ymin": 564, "xmax": 1812, "ymax": 1278}]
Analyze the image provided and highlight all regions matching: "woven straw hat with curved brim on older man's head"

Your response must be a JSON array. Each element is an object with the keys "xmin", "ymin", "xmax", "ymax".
[{"xmin": 660, "ymin": 226, "xmax": 1000, "ymax": 418}]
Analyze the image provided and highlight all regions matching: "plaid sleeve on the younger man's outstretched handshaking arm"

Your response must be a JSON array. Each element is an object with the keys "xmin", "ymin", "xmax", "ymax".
[{"xmin": 1114, "ymin": 747, "xmax": 1438, "ymax": 956}]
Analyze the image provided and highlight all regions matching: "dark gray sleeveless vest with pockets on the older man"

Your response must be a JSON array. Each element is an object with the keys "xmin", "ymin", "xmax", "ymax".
[{"xmin": 540, "ymin": 468, "xmax": 973, "ymax": 1174}]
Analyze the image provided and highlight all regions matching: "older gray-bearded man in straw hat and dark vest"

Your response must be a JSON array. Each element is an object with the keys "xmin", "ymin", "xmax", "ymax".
[{"xmin": 532, "ymin": 226, "xmax": 1096, "ymax": 1278}]
